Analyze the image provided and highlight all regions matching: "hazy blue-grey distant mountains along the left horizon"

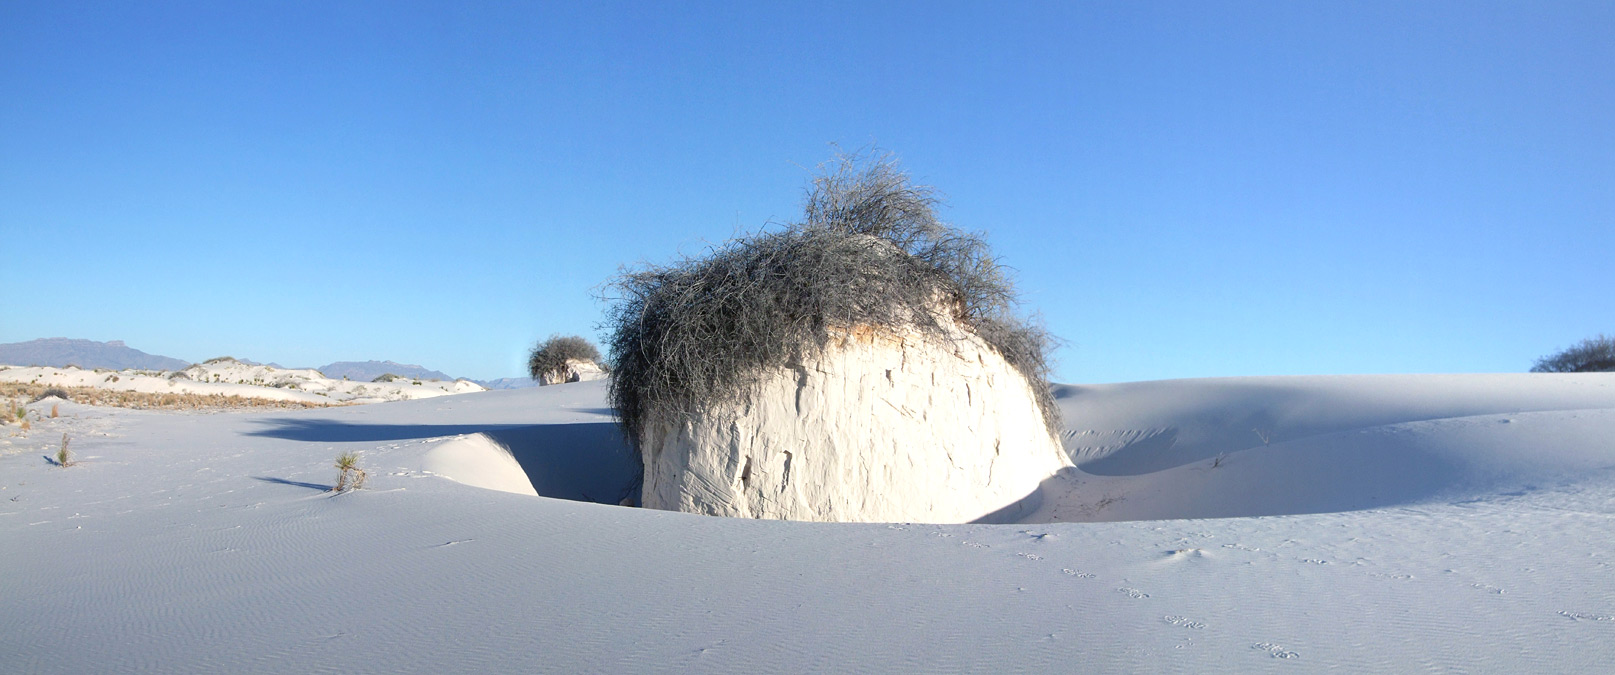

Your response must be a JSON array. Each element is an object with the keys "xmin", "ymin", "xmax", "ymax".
[{"xmin": 0, "ymin": 338, "xmax": 538, "ymax": 389}]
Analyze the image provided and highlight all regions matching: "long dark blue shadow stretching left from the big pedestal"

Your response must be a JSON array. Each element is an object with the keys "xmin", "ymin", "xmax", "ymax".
[{"xmin": 247, "ymin": 418, "xmax": 643, "ymax": 504}]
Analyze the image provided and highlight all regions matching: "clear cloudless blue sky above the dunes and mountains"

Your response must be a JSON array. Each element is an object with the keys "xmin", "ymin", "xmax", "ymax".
[{"xmin": 0, "ymin": 2, "xmax": 1615, "ymax": 383}]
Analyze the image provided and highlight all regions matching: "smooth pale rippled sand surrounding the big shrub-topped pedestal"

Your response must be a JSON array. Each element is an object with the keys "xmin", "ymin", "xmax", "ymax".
[{"xmin": 0, "ymin": 373, "xmax": 1615, "ymax": 673}]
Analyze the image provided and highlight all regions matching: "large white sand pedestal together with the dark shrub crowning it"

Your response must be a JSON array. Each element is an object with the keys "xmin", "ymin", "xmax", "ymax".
[{"xmin": 606, "ymin": 151, "xmax": 1069, "ymax": 522}]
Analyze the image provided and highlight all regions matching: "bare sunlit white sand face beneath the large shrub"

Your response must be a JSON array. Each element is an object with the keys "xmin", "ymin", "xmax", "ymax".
[{"xmin": 640, "ymin": 328, "xmax": 1069, "ymax": 523}]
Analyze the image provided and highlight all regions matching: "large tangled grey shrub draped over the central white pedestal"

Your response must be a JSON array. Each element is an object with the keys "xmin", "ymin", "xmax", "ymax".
[{"xmin": 604, "ymin": 148, "xmax": 1059, "ymax": 439}]
